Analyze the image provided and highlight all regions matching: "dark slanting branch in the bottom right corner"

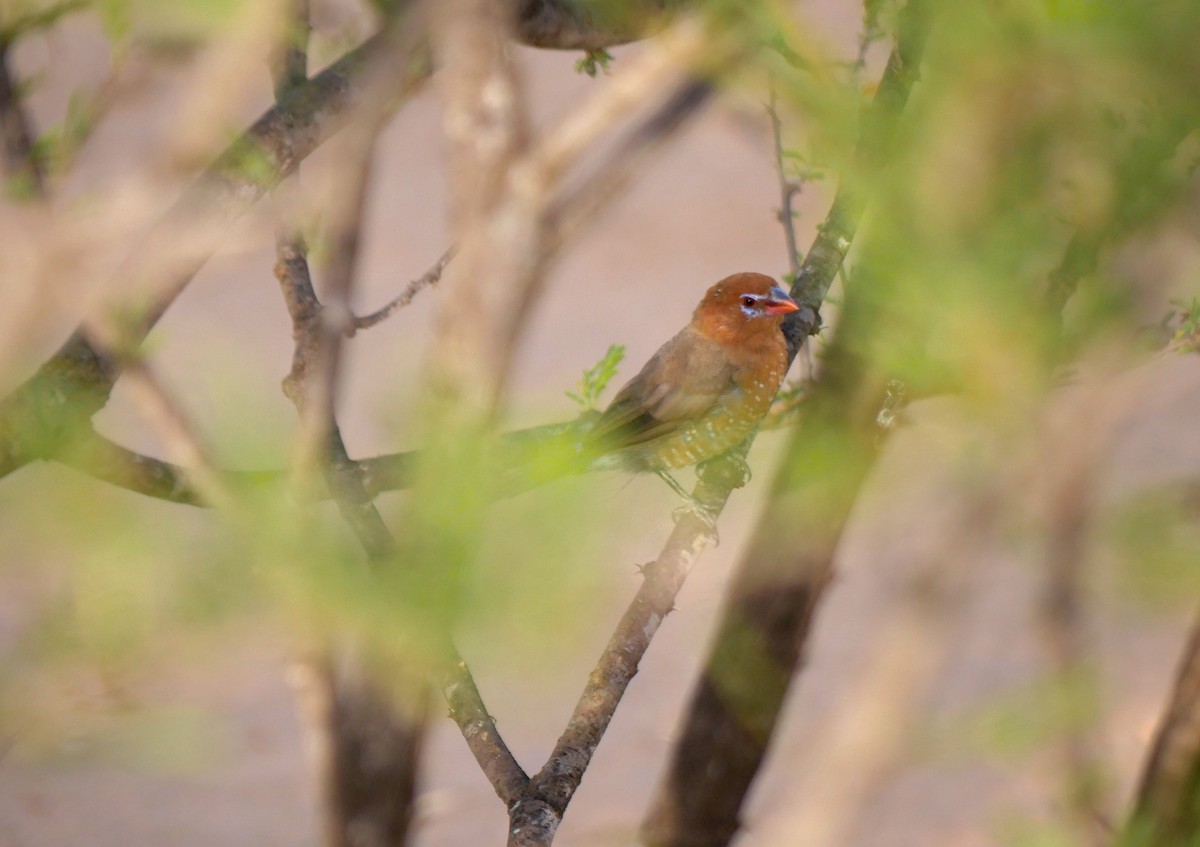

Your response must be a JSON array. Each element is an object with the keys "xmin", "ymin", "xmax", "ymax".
[{"xmin": 1127, "ymin": 618, "xmax": 1200, "ymax": 847}]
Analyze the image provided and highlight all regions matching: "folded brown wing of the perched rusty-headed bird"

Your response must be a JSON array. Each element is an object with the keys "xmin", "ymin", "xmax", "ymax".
[{"xmin": 589, "ymin": 326, "xmax": 734, "ymax": 450}]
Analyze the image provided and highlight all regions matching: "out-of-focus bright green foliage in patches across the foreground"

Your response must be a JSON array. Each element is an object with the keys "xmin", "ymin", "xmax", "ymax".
[{"xmin": 0, "ymin": 0, "xmax": 1200, "ymax": 820}]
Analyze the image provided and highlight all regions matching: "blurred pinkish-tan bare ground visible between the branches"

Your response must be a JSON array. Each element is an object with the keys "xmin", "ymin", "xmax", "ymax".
[{"xmin": 0, "ymin": 2, "xmax": 1200, "ymax": 847}]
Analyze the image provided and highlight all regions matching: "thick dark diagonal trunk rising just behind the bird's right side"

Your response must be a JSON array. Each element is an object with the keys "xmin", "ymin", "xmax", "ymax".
[{"xmin": 643, "ymin": 0, "xmax": 928, "ymax": 847}]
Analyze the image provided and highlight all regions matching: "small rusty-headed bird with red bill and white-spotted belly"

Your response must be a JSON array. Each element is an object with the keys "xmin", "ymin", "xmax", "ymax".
[{"xmin": 587, "ymin": 274, "xmax": 798, "ymax": 499}]
